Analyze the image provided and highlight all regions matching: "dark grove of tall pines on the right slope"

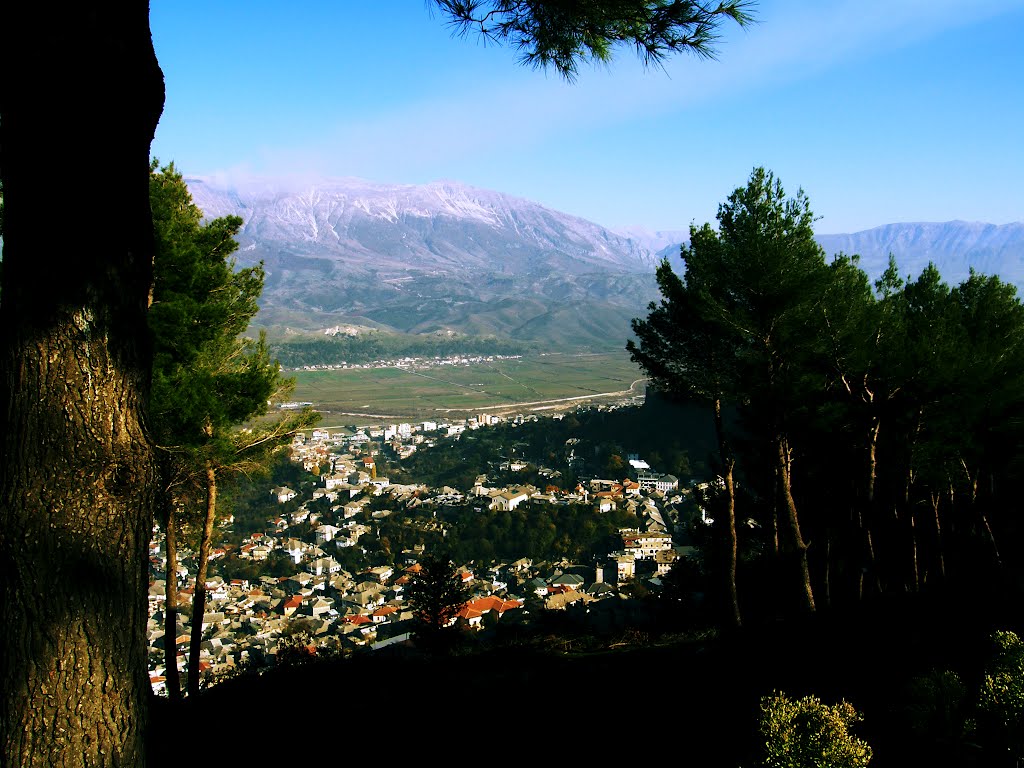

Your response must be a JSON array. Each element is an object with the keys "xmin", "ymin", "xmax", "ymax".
[{"xmin": 629, "ymin": 168, "xmax": 1024, "ymax": 626}]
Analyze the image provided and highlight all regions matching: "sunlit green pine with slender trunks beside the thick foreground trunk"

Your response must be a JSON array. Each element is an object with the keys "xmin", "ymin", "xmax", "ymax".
[{"xmin": 150, "ymin": 161, "xmax": 316, "ymax": 696}]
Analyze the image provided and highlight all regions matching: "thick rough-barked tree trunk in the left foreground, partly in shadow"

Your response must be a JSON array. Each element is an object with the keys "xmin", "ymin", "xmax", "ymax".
[{"xmin": 0, "ymin": 2, "xmax": 163, "ymax": 768}]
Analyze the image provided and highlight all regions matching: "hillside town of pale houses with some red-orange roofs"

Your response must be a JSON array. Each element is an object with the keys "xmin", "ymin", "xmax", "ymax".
[{"xmin": 148, "ymin": 415, "xmax": 702, "ymax": 695}]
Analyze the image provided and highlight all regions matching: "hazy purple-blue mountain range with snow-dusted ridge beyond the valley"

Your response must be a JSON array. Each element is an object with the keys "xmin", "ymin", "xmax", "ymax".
[{"xmin": 186, "ymin": 177, "xmax": 1024, "ymax": 350}]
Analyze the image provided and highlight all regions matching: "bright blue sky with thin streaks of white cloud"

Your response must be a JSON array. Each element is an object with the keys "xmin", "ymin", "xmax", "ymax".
[{"xmin": 151, "ymin": 0, "xmax": 1024, "ymax": 233}]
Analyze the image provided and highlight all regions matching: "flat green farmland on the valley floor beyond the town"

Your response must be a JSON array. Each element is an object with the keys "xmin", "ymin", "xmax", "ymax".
[{"xmin": 288, "ymin": 351, "xmax": 645, "ymax": 421}]
